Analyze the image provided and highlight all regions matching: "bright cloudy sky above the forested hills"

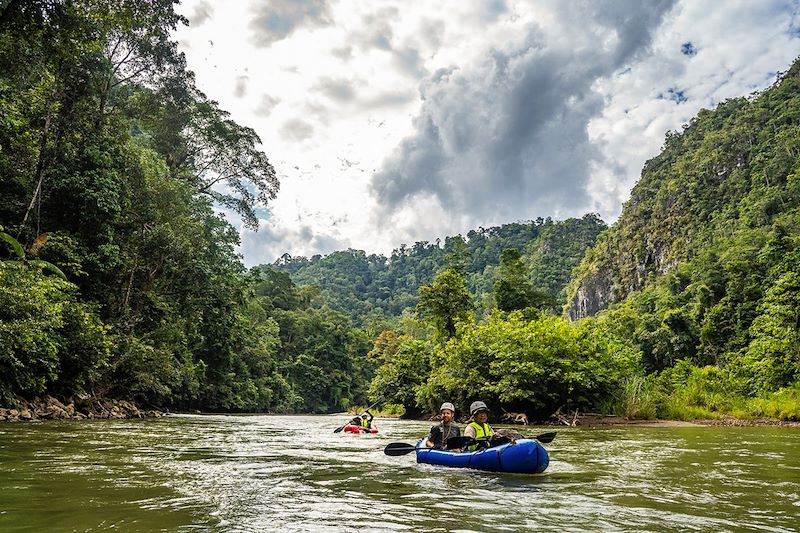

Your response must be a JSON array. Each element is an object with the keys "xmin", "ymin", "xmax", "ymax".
[{"xmin": 175, "ymin": 0, "xmax": 800, "ymax": 266}]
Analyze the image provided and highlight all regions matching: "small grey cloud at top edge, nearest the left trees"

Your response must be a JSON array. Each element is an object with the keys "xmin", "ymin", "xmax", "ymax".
[{"xmin": 250, "ymin": 0, "xmax": 332, "ymax": 47}]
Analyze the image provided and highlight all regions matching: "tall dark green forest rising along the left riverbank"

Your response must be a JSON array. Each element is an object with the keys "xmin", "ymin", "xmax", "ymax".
[{"xmin": 0, "ymin": 0, "xmax": 371, "ymax": 411}]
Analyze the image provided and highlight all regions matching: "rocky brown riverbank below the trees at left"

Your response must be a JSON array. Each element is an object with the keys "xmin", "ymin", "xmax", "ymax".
[{"xmin": 0, "ymin": 395, "xmax": 166, "ymax": 422}]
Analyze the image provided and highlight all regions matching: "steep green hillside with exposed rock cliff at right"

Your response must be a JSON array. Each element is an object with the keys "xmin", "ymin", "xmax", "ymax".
[{"xmin": 566, "ymin": 58, "xmax": 800, "ymax": 400}]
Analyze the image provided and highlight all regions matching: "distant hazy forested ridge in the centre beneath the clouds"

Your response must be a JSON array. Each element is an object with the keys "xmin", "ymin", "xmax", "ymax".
[{"xmin": 268, "ymin": 214, "xmax": 606, "ymax": 324}]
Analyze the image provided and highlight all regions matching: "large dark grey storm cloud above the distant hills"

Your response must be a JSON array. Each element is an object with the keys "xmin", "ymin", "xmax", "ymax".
[{"xmin": 371, "ymin": 1, "xmax": 673, "ymax": 227}]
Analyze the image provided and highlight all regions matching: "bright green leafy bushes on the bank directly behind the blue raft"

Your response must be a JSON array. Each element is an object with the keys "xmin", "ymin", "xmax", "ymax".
[{"xmin": 418, "ymin": 312, "xmax": 635, "ymax": 416}]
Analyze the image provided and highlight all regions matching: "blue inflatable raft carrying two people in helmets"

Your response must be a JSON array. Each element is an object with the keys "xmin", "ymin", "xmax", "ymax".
[{"xmin": 416, "ymin": 439, "xmax": 550, "ymax": 474}]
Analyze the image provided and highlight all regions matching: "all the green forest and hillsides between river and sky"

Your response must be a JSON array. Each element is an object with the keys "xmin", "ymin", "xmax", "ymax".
[{"xmin": 0, "ymin": 0, "xmax": 800, "ymax": 420}]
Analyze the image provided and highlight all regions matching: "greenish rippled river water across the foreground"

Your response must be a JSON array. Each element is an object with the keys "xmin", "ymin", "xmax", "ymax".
[{"xmin": 0, "ymin": 415, "xmax": 800, "ymax": 533}]
